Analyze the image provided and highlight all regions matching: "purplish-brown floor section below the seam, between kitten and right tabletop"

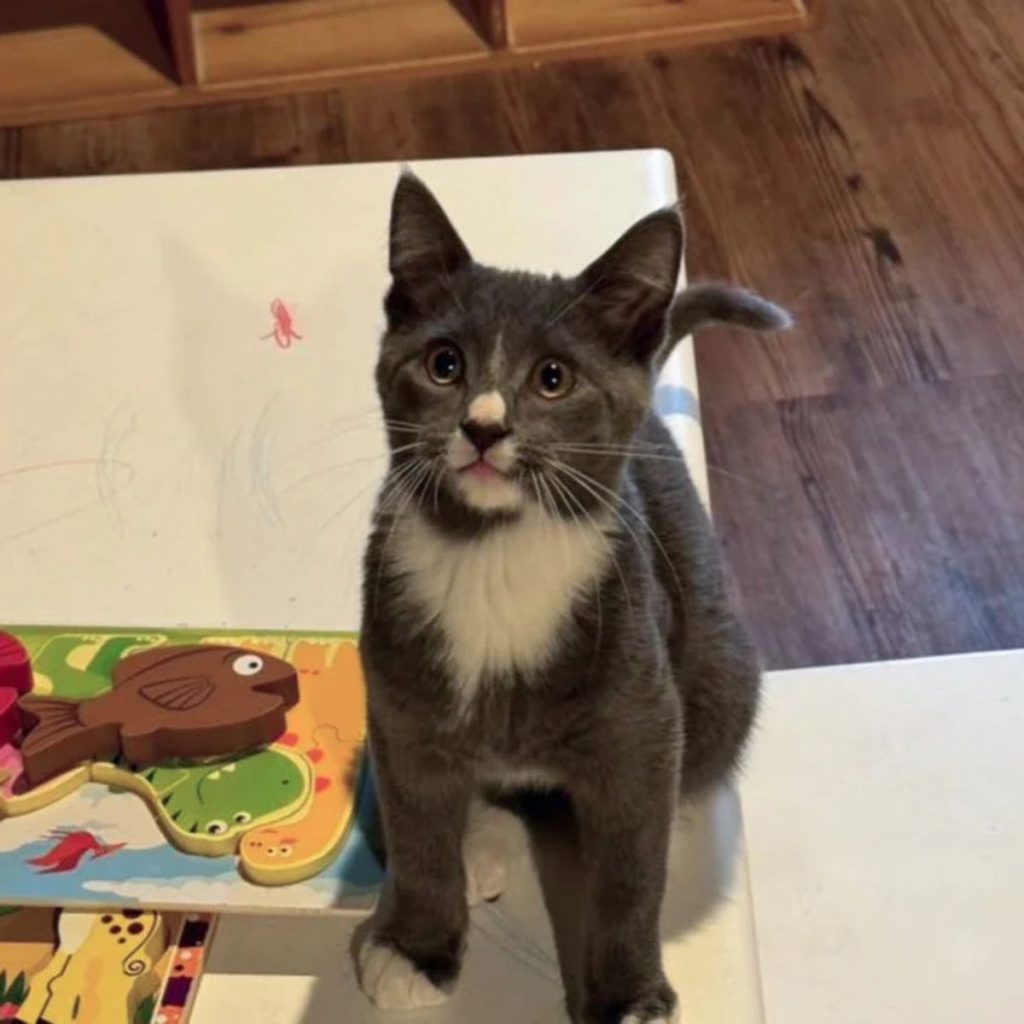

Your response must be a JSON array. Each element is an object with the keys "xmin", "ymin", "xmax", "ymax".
[{"xmin": 701, "ymin": 374, "xmax": 1024, "ymax": 667}]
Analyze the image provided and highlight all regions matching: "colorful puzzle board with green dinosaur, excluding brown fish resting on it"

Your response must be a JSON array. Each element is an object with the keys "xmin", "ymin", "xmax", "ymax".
[{"xmin": 0, "ymin": 627, "xmax": 381, "ymax": 910}]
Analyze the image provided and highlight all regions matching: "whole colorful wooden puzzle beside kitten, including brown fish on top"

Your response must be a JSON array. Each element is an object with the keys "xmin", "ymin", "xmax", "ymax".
[{"xmin": 0, "ymin": 627, "xmax": 381, "ymax": 913}]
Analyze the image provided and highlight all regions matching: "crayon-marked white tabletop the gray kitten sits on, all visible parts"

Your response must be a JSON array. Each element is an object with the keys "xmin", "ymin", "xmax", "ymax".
[{"xmin": 0, "ymin": 151, "xmax": 761, "ymax": 1024}]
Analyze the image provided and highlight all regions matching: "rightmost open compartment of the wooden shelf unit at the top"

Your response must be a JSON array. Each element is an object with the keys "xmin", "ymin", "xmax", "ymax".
[{"xmin": 506, "ymin": 0, "xmax": 808, "ymax": 52}]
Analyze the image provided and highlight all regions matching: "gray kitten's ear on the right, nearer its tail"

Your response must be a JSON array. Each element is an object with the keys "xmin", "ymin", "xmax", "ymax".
[{"xmin": 577, "ymin": 209, "xmax": 683, "ymax": 362}]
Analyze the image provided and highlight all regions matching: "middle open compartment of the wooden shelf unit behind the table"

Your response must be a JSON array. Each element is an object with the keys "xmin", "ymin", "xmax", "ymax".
[{"xmin": 193, "ymin": 0, "xmax": 487, "ymax": 87}]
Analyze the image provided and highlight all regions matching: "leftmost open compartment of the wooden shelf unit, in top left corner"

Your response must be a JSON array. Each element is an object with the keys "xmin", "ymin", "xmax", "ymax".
[{"xmin": 0, "ymin": 0, "xmax": 176, "ymax": 124}]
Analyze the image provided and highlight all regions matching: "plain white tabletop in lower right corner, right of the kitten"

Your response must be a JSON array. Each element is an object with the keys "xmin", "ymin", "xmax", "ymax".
[{"xmin": 742, "ymin": 651, "xmax": 1024, "ymax": 1024}]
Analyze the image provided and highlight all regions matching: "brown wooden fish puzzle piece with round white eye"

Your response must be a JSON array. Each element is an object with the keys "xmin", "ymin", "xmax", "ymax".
[{"xmin": 18, "ymin": 644, "xmax": 299, "ymax": 785}]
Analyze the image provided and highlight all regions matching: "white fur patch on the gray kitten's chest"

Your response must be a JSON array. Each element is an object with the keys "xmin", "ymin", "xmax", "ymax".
[{"xmin": 393, "ymin": 509, "xmax": 609, "ymax": 703}]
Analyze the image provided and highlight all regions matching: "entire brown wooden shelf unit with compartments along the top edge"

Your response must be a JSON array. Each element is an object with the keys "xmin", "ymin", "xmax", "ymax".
[{"xmin": 0, "ymin": 0, "xmax": 810, "ymax": 124}]
